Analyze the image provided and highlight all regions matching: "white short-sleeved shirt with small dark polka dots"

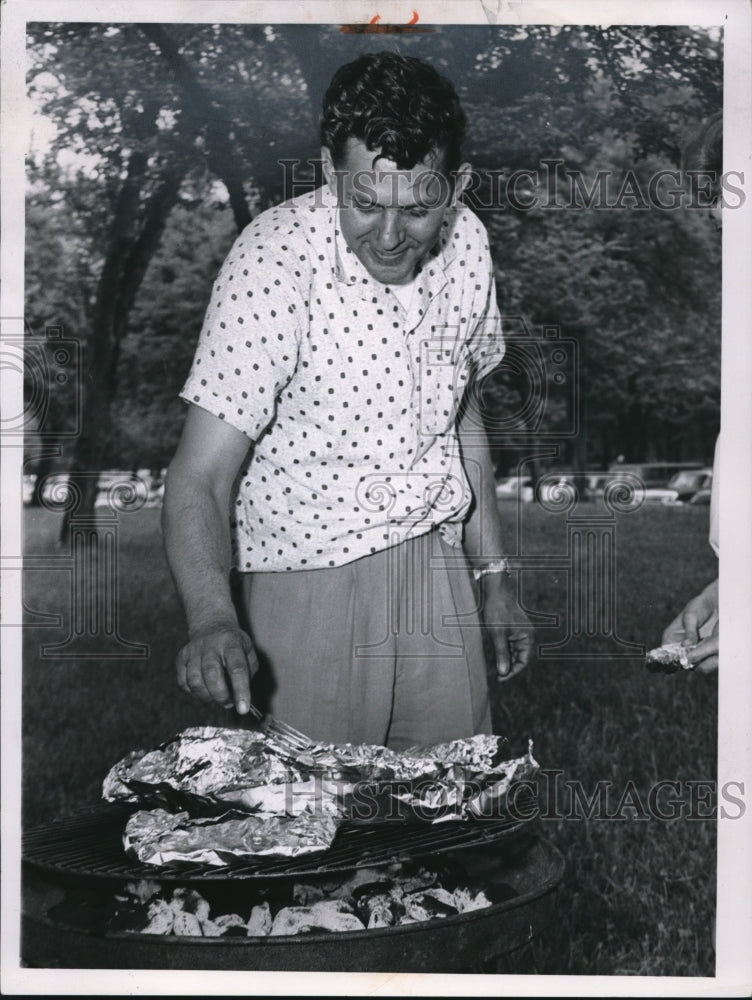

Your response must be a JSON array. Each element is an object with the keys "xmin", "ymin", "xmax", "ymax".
[{"xmin": 181, "ymin": 188, "xmax": 503, "ymax": 572}]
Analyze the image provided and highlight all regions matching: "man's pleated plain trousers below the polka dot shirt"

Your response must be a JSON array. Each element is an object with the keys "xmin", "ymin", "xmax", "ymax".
[{"xmin": 242, "ymin": 530, "xmax": 491, "ymax": 749}]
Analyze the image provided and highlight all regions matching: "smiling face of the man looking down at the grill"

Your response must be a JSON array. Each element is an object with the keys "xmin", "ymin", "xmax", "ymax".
[{"xmin": 321, "ymin": 139, "xmax": 469, "ymax": 285}]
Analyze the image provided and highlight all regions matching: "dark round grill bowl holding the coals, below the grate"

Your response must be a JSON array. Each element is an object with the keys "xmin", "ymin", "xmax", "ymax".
[{"xmin": 21, "ymin": 834, "xmax": 564, "ymax": 973}]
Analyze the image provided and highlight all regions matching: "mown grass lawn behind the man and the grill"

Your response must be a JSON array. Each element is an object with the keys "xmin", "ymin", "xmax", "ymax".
[{"xmin": 23, "ymin": 504, "xmax": 717, "ymax": 976}]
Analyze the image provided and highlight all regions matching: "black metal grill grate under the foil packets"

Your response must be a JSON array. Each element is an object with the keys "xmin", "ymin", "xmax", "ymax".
[{"xmin": 22, "ymin": 795, "xmax": 532, "ymax": 882}]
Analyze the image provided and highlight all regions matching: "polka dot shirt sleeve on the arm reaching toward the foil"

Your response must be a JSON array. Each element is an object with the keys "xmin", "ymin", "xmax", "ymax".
[{"xmin": 180, "ymin": 216, "xmax": 306, "ymax": 440}]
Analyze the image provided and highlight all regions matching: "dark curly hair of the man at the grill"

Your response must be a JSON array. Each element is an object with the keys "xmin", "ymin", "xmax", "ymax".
[{"xmin": 321, "ymin": 52, "xmax": 466, "ymax": 173}]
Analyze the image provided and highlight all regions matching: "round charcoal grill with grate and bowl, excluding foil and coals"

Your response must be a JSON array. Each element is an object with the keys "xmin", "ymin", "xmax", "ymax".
[{"xmin": 21, "ymin": 807, "xmax": 564, "ymax": 972}]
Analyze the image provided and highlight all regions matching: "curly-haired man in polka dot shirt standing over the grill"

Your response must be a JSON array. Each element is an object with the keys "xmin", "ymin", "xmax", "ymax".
[{"xmin": 164, "ymin": 53, "xmax": 532, "ymax": 748}]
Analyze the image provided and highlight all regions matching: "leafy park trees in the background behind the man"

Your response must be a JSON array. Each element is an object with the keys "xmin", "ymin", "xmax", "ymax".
[{"xmin": 27, "ymin": 22, "xmax": 722, "ymax": 484}]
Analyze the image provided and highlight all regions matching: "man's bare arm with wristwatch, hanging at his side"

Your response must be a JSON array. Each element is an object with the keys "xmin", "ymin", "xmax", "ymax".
[{"xmin": 457, "ymin": 400, "xmax": 534, "ymax": 681}]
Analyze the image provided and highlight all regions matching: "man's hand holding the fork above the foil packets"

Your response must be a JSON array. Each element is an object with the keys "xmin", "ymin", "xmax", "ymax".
[{"xmin": 175, "ymin": 625, "xmax": 258, "ymax": 715}]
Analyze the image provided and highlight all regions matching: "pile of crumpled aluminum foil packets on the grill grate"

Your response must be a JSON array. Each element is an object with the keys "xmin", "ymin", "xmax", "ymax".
[{"xmin": 103, "ymin": 727, "xmax": 538, "ymax": 865}]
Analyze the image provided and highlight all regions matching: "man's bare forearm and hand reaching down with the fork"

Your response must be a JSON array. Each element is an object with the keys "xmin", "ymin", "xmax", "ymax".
[{"xmin": 162, "ymin": 405, "xmax": 258, "ymax": 715}]
